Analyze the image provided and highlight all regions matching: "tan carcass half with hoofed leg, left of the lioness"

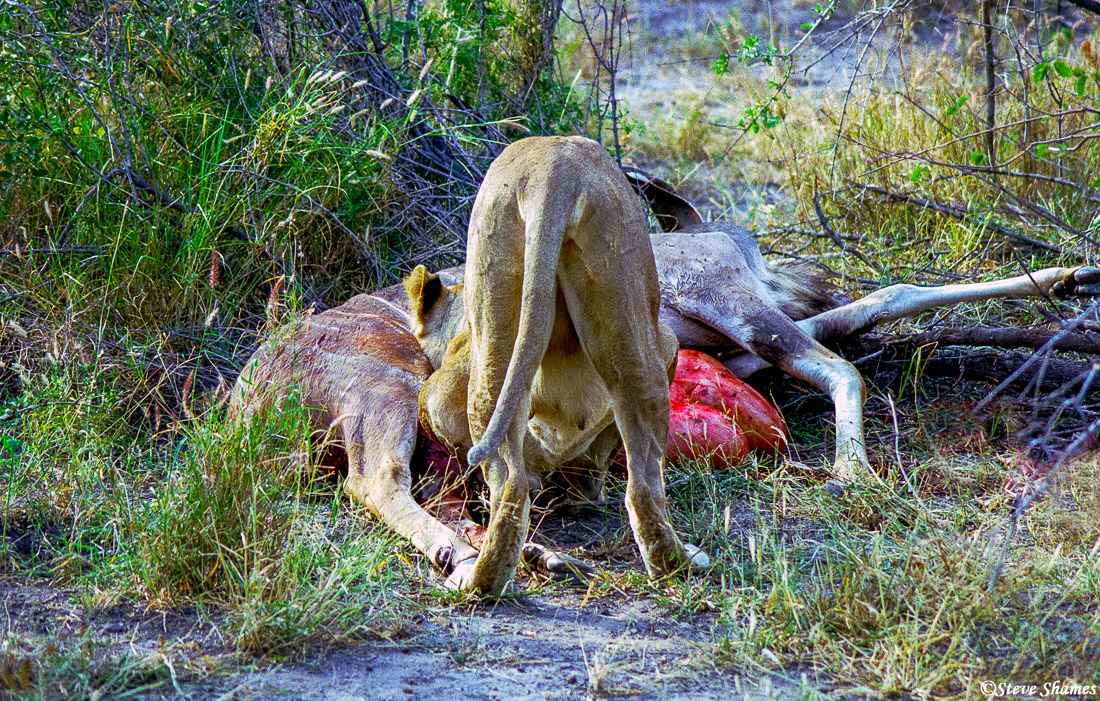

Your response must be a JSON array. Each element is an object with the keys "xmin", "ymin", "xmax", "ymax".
[{"xmin": 229, "ymin": 295, "xmax": 592, "ymax": 578}]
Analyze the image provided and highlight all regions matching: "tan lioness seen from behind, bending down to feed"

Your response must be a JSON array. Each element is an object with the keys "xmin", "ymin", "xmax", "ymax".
[{"xmin": 407, "ymin": 136, "xmax": 705, "ymax": 595}]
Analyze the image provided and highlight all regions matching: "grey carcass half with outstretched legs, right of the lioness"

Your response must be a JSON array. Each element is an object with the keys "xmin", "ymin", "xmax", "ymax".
[{"xmin": 627, "ymin": 171, "xmax": 1100, "ymax": 486}]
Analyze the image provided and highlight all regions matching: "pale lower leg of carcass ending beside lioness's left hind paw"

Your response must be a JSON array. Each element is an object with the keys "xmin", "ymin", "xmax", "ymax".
[{"xmin": 343, "ymin": 413, "xmax": 477, "ymax": 572}]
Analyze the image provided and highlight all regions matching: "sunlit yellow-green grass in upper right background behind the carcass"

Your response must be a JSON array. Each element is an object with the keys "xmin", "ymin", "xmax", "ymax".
[{"xmin": 630, "ymin": 4, "xmax": 1100, "ymax": 292}]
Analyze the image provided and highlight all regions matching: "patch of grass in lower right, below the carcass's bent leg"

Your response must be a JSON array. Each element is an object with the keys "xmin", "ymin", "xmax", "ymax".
[{"xmin": 638, "ymin": 437, "xmax": 1100, "ymax": 697}]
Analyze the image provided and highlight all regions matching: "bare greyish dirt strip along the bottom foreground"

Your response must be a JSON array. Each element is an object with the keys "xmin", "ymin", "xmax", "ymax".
[{"xmin": 0, "ymin": 527, "xmax": 827, "ymax": 701}]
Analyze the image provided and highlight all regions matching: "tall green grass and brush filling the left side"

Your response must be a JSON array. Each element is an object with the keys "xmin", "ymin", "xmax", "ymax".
[{"xmin": 0, "ymin": 0, "xmax": 585, "ymax": 682}]
